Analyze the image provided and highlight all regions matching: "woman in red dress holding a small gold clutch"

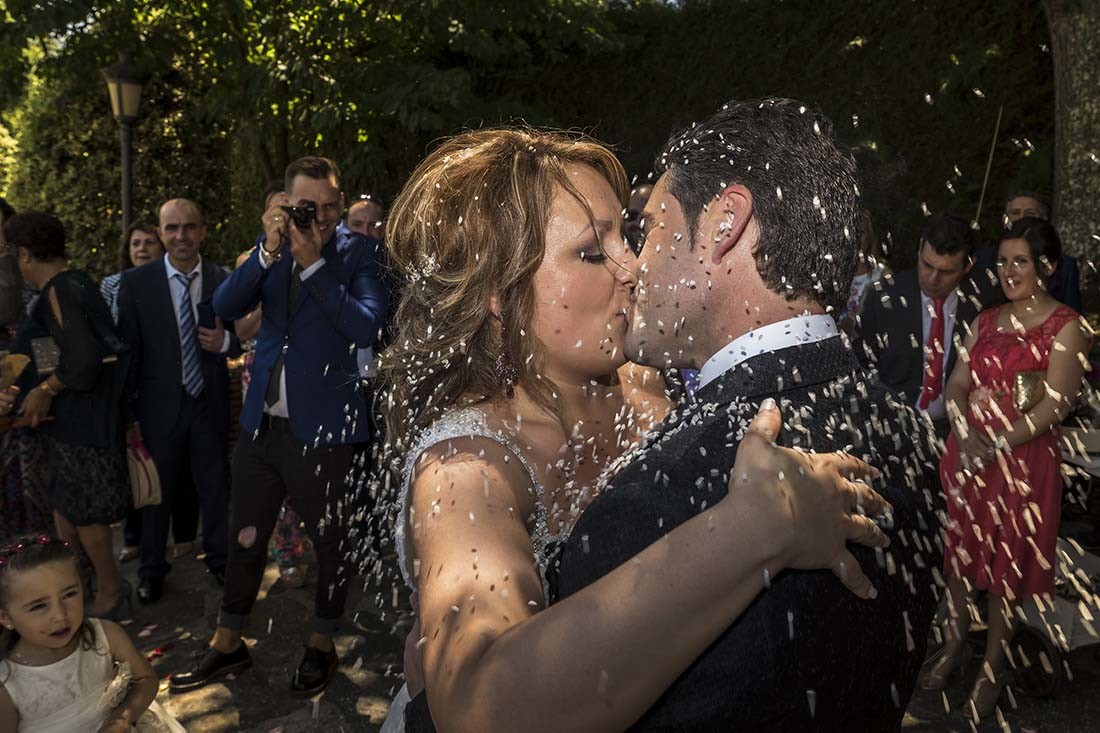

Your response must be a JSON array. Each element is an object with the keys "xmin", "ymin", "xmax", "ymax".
[{"xmin": 924, "ymin": 218, "xmax": 1091, "ymax": 718}]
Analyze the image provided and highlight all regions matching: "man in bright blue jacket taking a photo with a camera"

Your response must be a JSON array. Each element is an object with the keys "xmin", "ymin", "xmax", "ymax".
[{"xmin": 171, "ymin": 157, "xmax": 388, "ymax": 697}]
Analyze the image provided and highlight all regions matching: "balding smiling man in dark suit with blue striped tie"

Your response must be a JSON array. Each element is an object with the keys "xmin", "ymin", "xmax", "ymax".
[{"xmin": 119, "ymin": 198, "xmax": 239, "ymax": 603}]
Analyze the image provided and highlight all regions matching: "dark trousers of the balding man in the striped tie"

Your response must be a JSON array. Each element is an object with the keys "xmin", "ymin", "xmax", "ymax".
[{"xmin": 138, "ymin": 396, "xmax": 229, "ymax": 578}]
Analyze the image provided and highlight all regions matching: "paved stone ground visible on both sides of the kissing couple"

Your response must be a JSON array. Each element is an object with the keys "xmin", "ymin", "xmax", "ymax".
[{"xmin": 123, "ymin": 534, "xmax": 1100, "ymax": 733}]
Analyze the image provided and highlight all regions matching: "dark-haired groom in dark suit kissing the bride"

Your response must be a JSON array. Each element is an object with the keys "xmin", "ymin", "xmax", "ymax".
[{"xmin": 559, "ymin": 99, "xmax": 941, "ymax": 732}]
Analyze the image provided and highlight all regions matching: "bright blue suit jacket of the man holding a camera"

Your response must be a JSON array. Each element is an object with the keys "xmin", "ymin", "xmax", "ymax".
[{"xmin": 213, "ymin": 231, "xmax": 389, "ymax": 446}]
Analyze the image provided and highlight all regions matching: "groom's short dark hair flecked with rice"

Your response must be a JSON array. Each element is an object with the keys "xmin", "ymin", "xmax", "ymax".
[{"xmin": 656, "ymin": 99, "xmax": 862, "ymax": 309}]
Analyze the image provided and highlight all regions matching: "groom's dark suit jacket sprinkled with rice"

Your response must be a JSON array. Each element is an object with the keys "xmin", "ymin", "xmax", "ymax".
[{"xmin": 559, "ymin": 337, "xmax": 941, "ymax": 733}]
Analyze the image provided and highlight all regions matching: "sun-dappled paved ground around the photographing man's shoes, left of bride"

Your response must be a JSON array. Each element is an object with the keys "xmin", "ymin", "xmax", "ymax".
[{"xmin": 123, "ymin": 539, "xmax": 402, "ymax": 733}]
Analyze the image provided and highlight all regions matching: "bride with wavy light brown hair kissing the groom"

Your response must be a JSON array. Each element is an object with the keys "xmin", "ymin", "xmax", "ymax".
[{"xmin": 381, "ymin": 129, "xmax": 886, "ymax": 731}]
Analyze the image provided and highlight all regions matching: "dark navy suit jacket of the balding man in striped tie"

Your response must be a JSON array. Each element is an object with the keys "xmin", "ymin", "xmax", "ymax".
[{"xmin": 119, "ymin": 258, "xmax": 240, "ymax": 439}]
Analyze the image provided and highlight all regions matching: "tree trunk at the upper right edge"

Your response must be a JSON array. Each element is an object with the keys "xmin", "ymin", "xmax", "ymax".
[{"xmin": 1043, "ymin": 0, "xmax": 1100, "ymax": 277}]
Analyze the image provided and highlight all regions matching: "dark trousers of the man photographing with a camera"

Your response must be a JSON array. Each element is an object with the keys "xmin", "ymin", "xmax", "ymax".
[{"xmin": 218, "ymin": 415, "xmax": 356, "ymax": 634}]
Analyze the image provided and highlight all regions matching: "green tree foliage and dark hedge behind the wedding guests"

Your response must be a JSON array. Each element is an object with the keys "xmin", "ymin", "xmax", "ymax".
[{"xmin": 0, "ymin": 0, "xmax": 1053, "ymax": 273}]
